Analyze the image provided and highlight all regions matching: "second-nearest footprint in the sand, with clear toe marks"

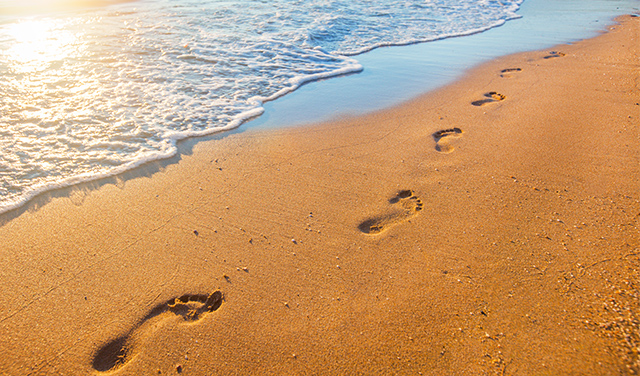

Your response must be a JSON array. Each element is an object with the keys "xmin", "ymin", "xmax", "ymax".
[{"xmin": 358, "ymin": 189, "xmax": 422, "ymax": 235}]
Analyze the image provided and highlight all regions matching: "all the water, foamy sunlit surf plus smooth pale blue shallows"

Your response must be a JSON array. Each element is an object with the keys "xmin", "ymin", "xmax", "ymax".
[{"xmin": 0, "ymin": 0, "xmax": 638, "ymax": 213}]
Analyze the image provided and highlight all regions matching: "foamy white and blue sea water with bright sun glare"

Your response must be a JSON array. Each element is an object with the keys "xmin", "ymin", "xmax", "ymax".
[{"xmin": 0, "ymin": 0, "xmax": 522, "ymax": 213}]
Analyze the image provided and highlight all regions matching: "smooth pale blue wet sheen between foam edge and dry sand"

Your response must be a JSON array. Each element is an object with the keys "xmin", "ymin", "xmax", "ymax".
[{"xmin": 246, "ymin": 0, "xmax": 640, "ymax": 128}]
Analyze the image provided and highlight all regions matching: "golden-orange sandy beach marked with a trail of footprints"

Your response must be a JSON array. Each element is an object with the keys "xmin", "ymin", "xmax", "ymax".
[{"xmin": 0, "ymin": 16, "xmax": 640, "ymax": 375}]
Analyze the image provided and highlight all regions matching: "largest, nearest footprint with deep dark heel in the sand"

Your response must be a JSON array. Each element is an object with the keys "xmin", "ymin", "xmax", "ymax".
[{"xmin": 93, "ymin": 291, "xmax": 222, "ymax": 372}]
